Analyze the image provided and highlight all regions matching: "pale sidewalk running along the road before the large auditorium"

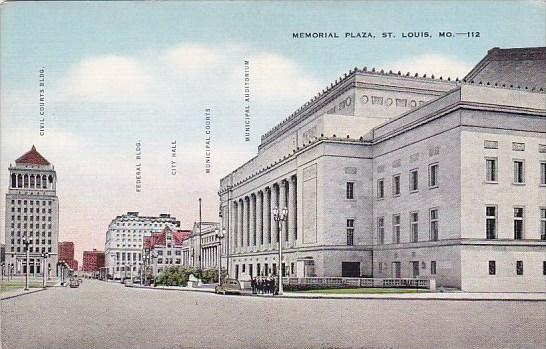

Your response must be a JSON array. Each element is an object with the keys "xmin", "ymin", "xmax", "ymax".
[{"xmin": 125, "ymin": 284, "xmax": 546, "ymax": 302}]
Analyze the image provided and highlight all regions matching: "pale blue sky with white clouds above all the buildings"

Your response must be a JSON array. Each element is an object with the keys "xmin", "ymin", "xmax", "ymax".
[{"xmin": 0, "ymin": 0, "xmax": 546, "ymax": 260}]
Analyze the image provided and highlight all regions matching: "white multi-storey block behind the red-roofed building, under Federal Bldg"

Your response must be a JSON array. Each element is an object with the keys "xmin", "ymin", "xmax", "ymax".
[{"xmin": 105, "ymin": 212, "xmax": 180, "ymax": 279}]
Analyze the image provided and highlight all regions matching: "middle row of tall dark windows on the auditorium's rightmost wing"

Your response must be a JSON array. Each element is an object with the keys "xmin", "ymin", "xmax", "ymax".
[{"xmin": 485, "ymin": 205, "xmax": 546, "ymax": 240}]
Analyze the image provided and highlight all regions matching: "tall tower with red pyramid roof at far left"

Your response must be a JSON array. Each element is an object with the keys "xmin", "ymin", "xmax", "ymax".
[{"xmin": 5, "ymin": 146, "xmax": 59, "ymax": 276}]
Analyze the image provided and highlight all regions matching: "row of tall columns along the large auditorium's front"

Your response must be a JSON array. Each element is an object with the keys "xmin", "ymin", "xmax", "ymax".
[{"xmin": 230, "ymin": 175, "xmax": 298, "ymax": 253}]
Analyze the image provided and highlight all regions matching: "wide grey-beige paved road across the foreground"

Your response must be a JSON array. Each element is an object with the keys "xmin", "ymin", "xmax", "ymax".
[{"xmin": 1, "ymin": 280, "xmax": 546, "ymax": 349}]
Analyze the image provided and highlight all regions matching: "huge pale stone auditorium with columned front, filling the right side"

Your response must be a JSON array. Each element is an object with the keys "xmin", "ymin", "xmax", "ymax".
[{"xmin": 219, "ymin": 48, "xmax": 546, "ymax": 291}]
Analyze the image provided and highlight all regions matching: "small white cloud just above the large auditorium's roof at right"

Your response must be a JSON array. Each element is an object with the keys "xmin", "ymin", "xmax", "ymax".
[{"xmin": 382, "ymin": 53, "xmax": 473, "ymax": 78}]
